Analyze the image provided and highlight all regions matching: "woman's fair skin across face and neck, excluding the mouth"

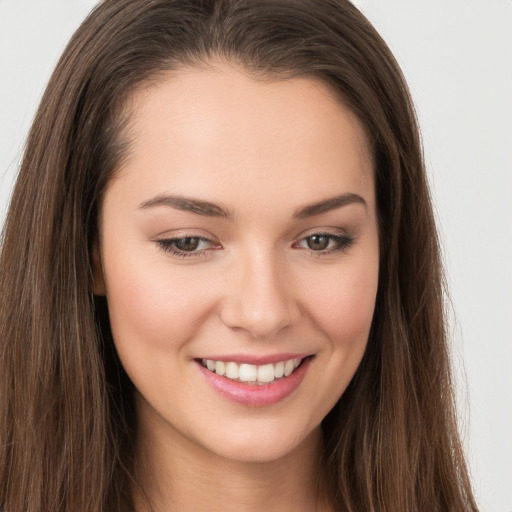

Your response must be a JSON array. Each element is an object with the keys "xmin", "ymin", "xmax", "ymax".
[{"xmin": 95, "ymin": 62, "xmax": 379, "ymax": 512}]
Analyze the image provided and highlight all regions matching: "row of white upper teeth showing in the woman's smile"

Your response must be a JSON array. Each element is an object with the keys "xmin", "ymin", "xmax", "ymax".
[{"xmin": 202, "ymin": 359, "xmax": 302, "ymax": 384}]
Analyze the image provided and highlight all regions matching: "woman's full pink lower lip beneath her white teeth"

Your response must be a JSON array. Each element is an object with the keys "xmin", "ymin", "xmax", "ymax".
[{"xmin": 196, "ymin": 357, "xmax": 312, "ymax": 407}]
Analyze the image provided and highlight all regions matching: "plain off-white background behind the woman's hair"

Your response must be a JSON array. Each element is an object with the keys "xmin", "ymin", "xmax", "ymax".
[{"xmin": 0, "ymin": 0, "xmax": 512, "ymax": 512}]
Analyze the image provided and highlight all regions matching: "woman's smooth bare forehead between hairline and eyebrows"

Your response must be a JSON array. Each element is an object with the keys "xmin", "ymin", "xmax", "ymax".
[{"xmin": 112, "ymin": 63, "xmax": 373, "ymax": 214}]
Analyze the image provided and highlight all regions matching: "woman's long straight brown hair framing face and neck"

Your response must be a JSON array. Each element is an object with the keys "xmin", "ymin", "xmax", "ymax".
[{"xmin": 0, "ymin": 0, "xmax": 477, "ymax": 512}]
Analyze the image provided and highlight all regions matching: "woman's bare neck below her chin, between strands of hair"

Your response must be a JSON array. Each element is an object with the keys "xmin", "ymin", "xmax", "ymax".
[{"xmin": 134, "ymin": 402, "xmax": 330, "ymax": 512}]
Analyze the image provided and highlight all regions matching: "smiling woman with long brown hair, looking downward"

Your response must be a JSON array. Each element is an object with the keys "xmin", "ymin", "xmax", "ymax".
[{"xmin": 0, "ymin": 0, "xmax": 476, "ymax": 511}]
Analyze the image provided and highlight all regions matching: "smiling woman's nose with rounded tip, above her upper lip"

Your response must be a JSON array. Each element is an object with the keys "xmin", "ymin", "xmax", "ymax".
[{"xmin": 220, "ymin": 249, "xmax": 300, "ymax": 339}]
